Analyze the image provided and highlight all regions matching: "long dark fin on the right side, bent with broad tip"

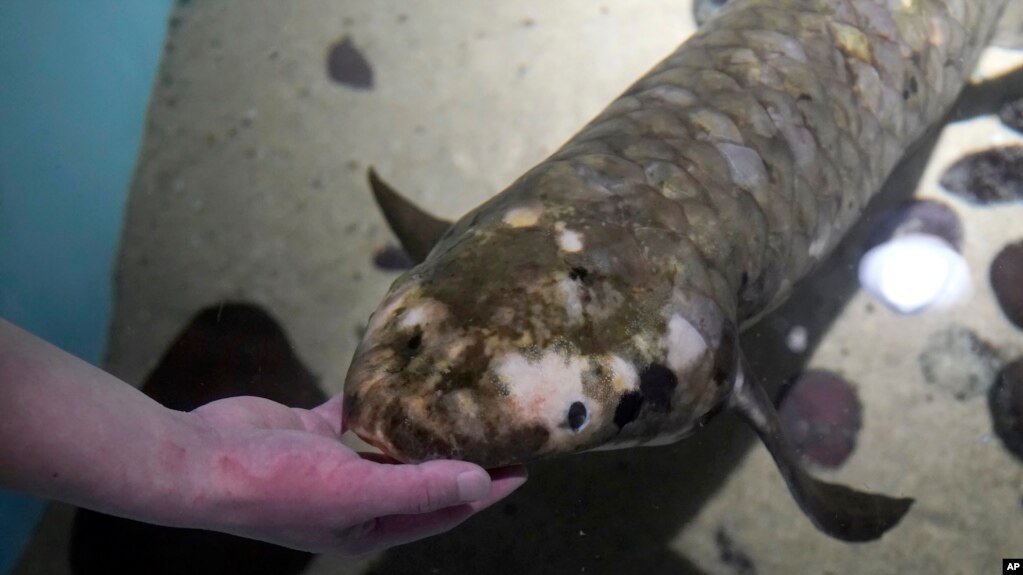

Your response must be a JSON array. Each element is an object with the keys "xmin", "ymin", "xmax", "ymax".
[{"xmin": 730, "ymin": 354, "xmax": 913, "ymax": 541}]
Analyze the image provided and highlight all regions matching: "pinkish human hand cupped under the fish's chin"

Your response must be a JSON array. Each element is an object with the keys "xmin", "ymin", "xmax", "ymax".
[{"xmin": 183, "ymin": 396, "xmax": 526, "ymax": 555}]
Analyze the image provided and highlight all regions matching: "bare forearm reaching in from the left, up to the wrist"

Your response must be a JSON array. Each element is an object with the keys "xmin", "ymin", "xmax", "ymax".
[{"xmin": 0, "ymin": 320, "xmax": 209, "ymax": 525}]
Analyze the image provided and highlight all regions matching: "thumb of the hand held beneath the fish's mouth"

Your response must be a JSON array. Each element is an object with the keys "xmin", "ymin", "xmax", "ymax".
[{"xmin": 366, "ymin": 460, "xmax": 491, "ymax": 517}]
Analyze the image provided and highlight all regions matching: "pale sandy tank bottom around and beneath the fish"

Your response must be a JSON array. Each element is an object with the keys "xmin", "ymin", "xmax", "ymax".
[{"xmin": 17, "ymin": 0, "xmax": 1023, "ymax": 575}]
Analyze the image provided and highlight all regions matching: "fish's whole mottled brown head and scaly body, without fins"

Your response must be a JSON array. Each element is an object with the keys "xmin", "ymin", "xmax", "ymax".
[{"xmin": 345, "ymin": 0, "xmax": 1005, "ymax": 467}]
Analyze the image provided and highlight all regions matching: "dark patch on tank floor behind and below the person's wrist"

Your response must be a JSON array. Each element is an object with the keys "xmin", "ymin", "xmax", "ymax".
[{"xmin": 69, "ymin": 303, "xmax": 326, "ymax": 575}]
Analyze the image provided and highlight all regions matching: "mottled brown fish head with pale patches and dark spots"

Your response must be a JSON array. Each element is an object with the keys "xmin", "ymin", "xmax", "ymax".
[{"xmin": 344, "ymin": 195, "xmax": 735, "ymax": 467}]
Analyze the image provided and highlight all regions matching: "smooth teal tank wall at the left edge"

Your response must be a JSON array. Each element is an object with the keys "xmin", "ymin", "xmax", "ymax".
[{"xmin": 0, "ymin": 0, "xmax": 172, "ymax": 575}]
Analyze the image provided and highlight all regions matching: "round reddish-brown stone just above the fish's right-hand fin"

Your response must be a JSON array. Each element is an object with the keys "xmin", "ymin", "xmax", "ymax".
[{"xmin": 779, "ymin": 369, "xmax": 862, "ymax": 468}]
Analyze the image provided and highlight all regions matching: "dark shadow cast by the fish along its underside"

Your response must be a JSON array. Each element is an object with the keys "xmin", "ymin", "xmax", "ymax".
[{"xmin": 368, "ymin": 116, "xmax": 939, "ymax": 575}]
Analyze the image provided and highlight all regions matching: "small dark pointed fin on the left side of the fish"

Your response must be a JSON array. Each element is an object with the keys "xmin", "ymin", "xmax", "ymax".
[{"xmin": 369, "ymin": 168, "xmax": 451, "ymax": 263}]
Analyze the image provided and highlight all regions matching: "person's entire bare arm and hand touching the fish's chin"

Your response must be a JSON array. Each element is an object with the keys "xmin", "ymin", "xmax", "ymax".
[{"xmin": 0, "ymin": 319, "xmax": 526, "ymax": 555}]
